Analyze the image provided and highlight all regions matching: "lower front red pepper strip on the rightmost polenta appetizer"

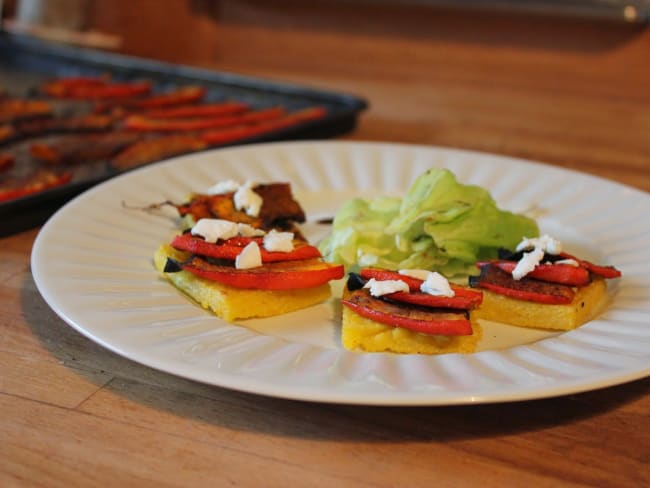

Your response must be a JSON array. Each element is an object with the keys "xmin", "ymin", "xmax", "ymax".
[{"xmin": 470, "ymin": 264, "xmax": 575, "ymax": 305}]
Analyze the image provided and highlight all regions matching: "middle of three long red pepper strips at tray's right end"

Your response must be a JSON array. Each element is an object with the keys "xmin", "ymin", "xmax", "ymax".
[{"xmin": 124, "ymin": 107, "xmax": 285, "ymax": 132}]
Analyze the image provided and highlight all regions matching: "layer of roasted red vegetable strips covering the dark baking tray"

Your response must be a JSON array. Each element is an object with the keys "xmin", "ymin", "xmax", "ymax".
[{"xmin": 0, "ymin": 75, "xmax": 327, "ymax": 206}]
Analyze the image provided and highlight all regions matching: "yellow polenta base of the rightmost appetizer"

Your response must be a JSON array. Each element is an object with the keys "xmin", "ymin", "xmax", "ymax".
[{"xmin": 472, "ymin": 279, "xmax": 607, "ymax": 330}]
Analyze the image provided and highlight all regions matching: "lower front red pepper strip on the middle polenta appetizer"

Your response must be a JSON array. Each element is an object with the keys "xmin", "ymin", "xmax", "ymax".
[{"xmin": 341, "ymin": 288, "xmax": 472, "ymax": 336}]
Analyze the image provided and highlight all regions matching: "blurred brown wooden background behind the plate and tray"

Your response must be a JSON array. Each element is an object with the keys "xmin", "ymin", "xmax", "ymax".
[{"xmin": 3, "ymin": 0, "xmax": 650, "ymax": 190}]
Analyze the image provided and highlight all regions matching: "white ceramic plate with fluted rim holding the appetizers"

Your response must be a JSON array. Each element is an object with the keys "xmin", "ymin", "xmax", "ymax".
[{"xmin": 32, "ymin": 142, "xmax": 650, "ymax": 405}]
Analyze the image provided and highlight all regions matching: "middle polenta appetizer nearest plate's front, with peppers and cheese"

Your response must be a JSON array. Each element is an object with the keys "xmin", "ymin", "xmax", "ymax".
[{"xmin": 341, "ymin": 268, "xmax": 482, "ymax": 354}]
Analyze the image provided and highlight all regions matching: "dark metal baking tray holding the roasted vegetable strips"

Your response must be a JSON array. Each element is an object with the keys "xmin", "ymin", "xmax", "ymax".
[{"xmin": 0, "ymin": 32, "xmax": 368, "ymax": 236}]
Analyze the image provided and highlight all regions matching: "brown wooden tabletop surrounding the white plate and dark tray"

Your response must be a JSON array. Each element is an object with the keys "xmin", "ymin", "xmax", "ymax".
[{"xmin": 0, "ymin": 1, "xmax": 650, "ymax": 487}]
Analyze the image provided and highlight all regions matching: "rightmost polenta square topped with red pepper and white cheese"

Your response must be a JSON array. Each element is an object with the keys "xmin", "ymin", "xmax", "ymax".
[{"xmin": 470, "ymin": 235, "xmax": 621, "ymax": 330}]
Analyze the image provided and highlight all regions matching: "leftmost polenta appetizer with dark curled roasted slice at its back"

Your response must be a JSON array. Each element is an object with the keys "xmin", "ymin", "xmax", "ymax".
[{"xmin": 154, "ymin": 181, "xmax": 344, "ymax": 321}]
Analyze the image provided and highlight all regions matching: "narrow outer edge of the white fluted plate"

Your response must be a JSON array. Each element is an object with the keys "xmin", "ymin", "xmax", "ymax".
[{"xmin": 30, "ymin": 141, "xmax": 650, "ymax": 406}]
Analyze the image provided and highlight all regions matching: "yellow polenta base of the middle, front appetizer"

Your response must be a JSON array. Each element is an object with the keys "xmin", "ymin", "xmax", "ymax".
[{"xmin": 341, "ymin": 306, "xmax": 483, "ymax": 354}]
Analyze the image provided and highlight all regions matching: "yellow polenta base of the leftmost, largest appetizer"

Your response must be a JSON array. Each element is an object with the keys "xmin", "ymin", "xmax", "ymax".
[{"xmin": 154, "ymin": 244, "xmax": 331, "ymax": 321}]
